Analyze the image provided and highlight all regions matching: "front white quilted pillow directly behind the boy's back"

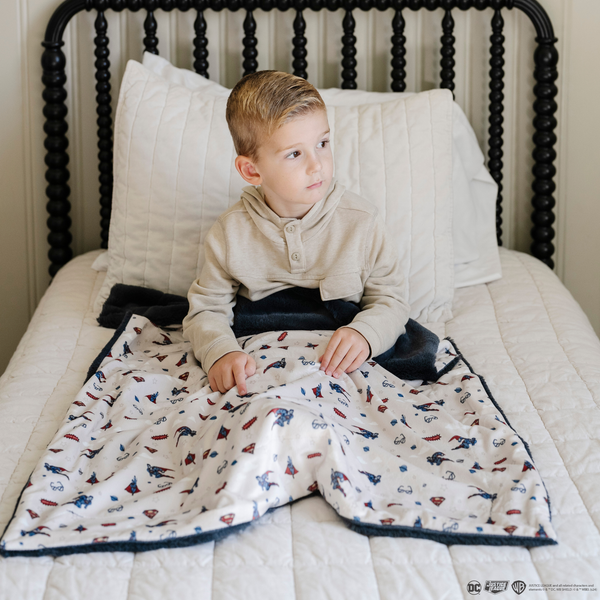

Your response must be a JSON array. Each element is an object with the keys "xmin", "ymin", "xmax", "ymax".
[{"xmin": 97, "ymin": 61, "xmax": 454, "ymax": 322}]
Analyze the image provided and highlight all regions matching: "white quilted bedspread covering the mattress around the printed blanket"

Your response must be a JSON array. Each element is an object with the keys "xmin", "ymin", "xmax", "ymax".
[{"xmin": 0, "ymin": 249, "xmax": 600, "ymax": 600}]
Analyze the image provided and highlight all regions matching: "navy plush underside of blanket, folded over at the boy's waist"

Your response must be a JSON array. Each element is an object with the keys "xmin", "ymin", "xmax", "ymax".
[{"xmin": 98, "ymin": 283, "xmax": 446, "ymax": 381}]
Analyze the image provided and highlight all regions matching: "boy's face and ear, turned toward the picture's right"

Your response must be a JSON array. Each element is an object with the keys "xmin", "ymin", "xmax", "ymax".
[{"xmin": 236, "ymin": 110, "xmax": 333, "ymax": 219}]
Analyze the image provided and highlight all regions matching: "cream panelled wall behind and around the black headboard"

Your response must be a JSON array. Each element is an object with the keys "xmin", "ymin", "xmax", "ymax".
[{"xmin": 0, "ymin": 0, "xmax": 600, "ymax": 373}]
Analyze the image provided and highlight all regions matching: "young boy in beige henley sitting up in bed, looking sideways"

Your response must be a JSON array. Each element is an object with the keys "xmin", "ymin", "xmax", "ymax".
[{"xmin": 183, "ymin": 71, "xmax": 409, "ymax": 395}]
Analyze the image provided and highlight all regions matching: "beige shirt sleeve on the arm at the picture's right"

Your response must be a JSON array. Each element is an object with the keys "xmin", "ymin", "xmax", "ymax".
[{"xmin": 346, "ymin": 216, "xmax": 410, "ymax": 358}]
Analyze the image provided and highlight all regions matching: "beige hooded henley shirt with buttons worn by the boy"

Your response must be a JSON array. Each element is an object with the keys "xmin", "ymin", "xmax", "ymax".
[{"xmin": 183, "ymin": 181, "xmax": 409, "ymax": 372}]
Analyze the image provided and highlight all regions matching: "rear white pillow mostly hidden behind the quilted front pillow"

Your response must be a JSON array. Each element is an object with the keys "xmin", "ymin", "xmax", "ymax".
[{"xmin": 143, "ymin": 52, "xmax": 502, "ymax": 288}]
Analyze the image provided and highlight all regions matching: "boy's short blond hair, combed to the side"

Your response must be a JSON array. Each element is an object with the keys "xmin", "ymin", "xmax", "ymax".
[{"xmin": 225, "ymin": 71, "xmax": 326, "ymax": 160}]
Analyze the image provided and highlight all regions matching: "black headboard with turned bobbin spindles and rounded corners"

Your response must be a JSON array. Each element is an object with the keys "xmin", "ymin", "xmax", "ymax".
[{"xmin": 42, "ymin": 0, "xmax": 558, "ymax": 276}]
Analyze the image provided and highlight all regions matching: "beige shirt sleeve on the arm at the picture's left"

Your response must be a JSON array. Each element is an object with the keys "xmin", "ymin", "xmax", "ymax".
[{"xmin": 183, "ymin": 221, "xmax": 243, "ymax": 373}]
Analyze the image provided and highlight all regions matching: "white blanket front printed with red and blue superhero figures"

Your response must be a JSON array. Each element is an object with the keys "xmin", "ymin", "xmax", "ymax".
[{"xmin": 0, "ymin": 316, "xmax": 556, "ymax": 556}]
